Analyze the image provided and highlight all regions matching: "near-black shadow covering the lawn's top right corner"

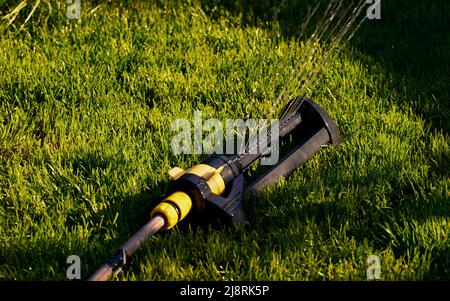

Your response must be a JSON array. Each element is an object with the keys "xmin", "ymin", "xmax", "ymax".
[{"xmin": 352, "ymin": 0, "xmax": 450, "ymax": 134}]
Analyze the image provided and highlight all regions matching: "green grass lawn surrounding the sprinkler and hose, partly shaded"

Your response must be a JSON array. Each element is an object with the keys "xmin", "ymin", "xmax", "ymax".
[{"xmin": 0, "ymin": 1, "xmax": 450, "ymax": 280}]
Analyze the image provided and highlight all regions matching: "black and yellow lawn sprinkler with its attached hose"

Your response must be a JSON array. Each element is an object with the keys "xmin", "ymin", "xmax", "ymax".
[{"xmin": 89, "ymin": 97, "xmax": 340, "ymax": 281}]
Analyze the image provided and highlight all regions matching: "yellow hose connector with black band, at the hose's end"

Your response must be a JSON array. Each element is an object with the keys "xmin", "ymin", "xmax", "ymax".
[{"xmin": 151, "ymin": 191, "xmax": 192, "ymax": 230}]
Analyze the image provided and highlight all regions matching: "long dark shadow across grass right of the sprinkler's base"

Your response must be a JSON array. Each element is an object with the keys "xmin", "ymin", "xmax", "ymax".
[{"xmin": 243, "ymin": 178, "xmax": 450, "ymax": 280}]
